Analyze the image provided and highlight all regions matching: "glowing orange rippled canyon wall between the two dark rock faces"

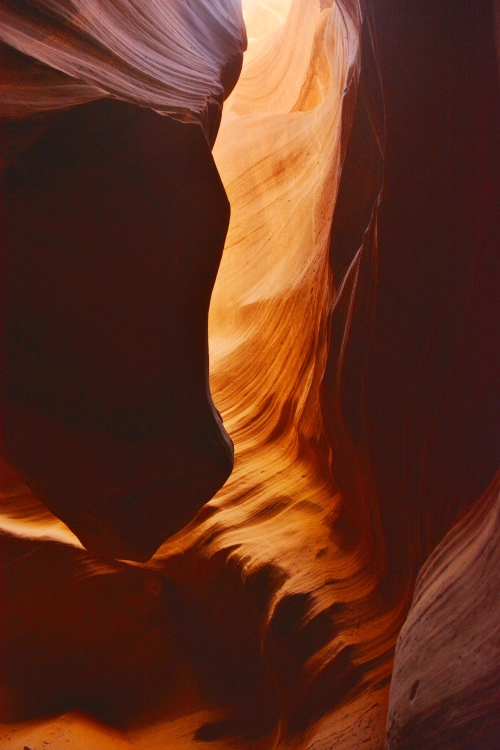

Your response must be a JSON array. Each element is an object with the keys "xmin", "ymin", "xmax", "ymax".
[{"xmin": 158, "ymin": 2, "xmax": 398, "ymax": 746}]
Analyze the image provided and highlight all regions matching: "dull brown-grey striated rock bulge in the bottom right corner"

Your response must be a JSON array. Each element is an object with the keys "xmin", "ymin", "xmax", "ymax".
[{"xmin": 386, "ymin": 477, "xmax": 500, "ymax": 750}]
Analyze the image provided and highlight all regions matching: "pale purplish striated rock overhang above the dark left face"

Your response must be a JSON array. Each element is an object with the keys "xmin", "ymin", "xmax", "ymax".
[{"xmin": 0, "ymin": 0, "xmax": 246, "ymax": 120}]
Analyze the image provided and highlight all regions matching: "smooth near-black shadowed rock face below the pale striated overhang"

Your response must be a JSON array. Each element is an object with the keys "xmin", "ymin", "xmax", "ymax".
[{"xmin": 3, "ymin": 100, "xmax": 232, "ymax": 560}]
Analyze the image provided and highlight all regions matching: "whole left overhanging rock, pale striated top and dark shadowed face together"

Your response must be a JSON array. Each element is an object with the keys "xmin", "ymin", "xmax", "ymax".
[{"xmin": 2, "ymin": 2, "xmax": 245, "ymax": 560}]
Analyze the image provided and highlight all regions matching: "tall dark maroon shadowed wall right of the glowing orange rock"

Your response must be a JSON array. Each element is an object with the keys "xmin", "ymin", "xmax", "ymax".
[{"xmin": 324, "ymin": 3, "xmax": 499, "ymax": 580}]
